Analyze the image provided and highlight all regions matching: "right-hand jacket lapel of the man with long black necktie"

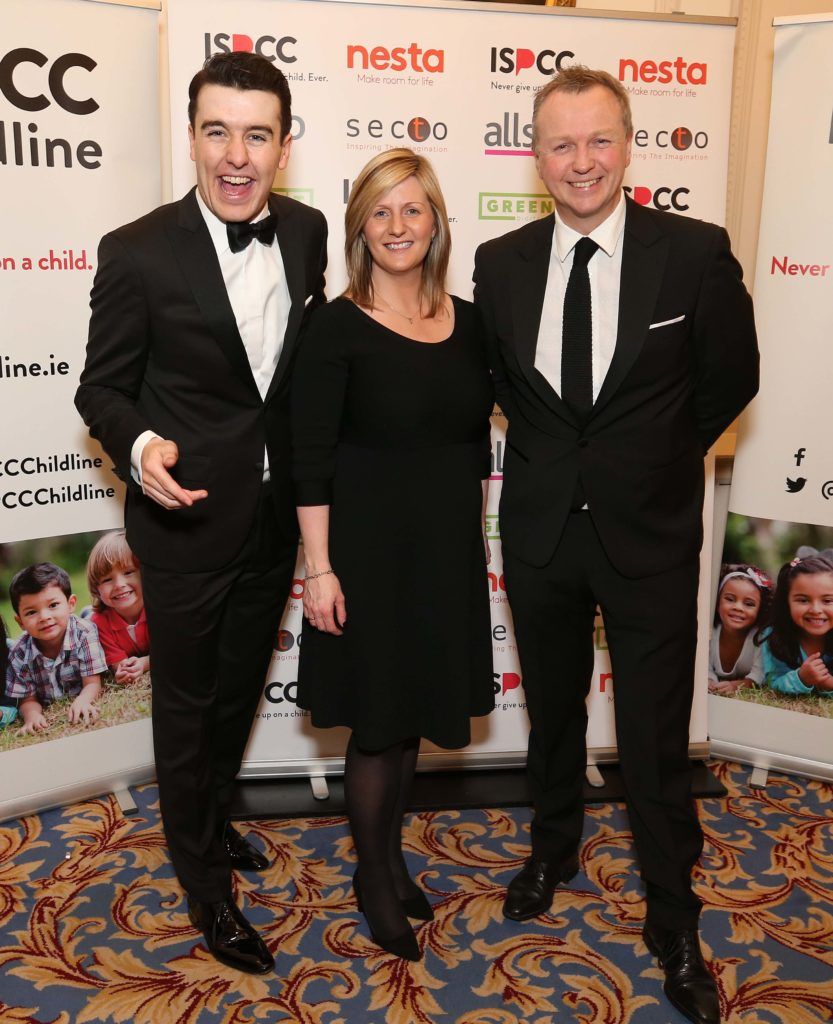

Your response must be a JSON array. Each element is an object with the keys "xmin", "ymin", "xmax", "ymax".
[{"xmin": 593, "ymin": 199, "xmax": 668, "ymax": 416}]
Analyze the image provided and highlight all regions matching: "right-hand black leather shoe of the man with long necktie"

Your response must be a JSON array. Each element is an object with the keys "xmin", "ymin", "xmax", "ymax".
[{"xmin": 642, "ymin": 925, "xmax": 720, "ymax": 1024}]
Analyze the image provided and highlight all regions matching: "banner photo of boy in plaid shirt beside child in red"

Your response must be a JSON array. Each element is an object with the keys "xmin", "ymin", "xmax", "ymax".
[{"xmin": 0, "ymin": 529, "xmax": 151, "ymax": 753}]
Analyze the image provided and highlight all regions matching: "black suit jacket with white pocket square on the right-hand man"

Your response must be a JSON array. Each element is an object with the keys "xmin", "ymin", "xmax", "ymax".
[{"xmin": 474, "ymin": 200, "xmax": 758, "ymax": 579}]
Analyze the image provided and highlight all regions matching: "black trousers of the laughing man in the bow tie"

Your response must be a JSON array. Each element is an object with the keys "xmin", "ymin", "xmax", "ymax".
[{"xmin": 141, "ymin": 484, "xmax": 297, "ymax": 902}]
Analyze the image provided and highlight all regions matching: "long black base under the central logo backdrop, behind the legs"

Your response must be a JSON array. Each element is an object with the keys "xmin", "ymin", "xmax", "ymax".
[{"xmin": 230, "ymin": 761, "xmax": 726, "ymax": 818}]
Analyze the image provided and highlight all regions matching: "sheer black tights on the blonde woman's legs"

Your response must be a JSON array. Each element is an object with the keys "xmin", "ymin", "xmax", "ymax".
[{"xmin": 344, "ymin": 735, "xmax": 419, "ymax": 937}]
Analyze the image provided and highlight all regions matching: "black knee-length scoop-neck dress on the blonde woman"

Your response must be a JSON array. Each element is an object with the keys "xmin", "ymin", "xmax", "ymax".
[{"xmin": 293, "ymin": 298, "xmax": 494, "ymax": 750}]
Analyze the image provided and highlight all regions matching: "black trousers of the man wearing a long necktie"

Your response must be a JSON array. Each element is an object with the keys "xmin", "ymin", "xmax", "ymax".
[{"xmin": 504, "ymin": 511, "xmax": 703, "ymax": 929}]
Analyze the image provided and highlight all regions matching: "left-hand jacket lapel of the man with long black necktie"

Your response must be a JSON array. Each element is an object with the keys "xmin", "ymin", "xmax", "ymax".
[{"xmin": 511, "ymin": 214, "xmax": 578, "ymax": 425}]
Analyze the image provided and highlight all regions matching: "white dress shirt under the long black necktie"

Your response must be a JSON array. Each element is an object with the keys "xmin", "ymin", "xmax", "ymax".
[{"xmin": 535, "ymin": 193, "xmax": 625, "ymax": 401}]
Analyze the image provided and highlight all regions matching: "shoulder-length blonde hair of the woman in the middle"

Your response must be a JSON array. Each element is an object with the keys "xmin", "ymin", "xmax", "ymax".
[{"xmin": 344, "ymin": 148, "xmax": 451, "ymax": 316}]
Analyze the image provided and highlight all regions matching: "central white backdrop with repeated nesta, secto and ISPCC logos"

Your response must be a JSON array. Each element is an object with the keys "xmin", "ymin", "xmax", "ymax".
[{"xmin": 168, "ymin": 0, "xmax": 734, "ymax": 774}]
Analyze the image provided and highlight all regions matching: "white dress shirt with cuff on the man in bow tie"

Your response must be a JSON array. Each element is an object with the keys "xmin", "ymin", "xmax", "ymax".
[{"xmin": 130, "ymin": 191, "xmax": 290, "ymax": 484}]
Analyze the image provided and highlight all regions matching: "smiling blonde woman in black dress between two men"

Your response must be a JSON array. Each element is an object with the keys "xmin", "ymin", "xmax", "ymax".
[{"xmin": 292, "ymin": 150, "xmax": 494, "ymax": 959}]
